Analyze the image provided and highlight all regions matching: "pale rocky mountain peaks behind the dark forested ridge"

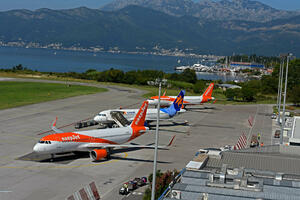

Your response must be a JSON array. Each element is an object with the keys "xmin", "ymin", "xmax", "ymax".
[{"xmin": 101, "ymin": 0, "xmax": 300, "ymax": 22}]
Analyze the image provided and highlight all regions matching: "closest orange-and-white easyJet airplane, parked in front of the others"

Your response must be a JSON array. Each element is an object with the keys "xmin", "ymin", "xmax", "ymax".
[{"xmin": 33, "ymin": 101, "xmax": 175, "ymax": 161}]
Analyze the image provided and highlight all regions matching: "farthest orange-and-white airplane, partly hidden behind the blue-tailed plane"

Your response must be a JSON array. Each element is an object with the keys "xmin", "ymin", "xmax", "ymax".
[{"xmin": 148, "ymin": 83, "xmax": 215, "ymax": 107}]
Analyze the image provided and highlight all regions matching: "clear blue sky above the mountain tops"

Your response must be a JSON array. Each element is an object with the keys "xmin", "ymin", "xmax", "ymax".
[{"xmin": 0, "ymin": 0, "xmax": 300, "ymax": 11}]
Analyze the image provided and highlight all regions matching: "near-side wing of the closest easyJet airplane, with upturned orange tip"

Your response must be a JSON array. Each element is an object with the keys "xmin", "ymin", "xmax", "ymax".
[{"xmin": 80, "ymin": 136, "xmax": 175, "ymax": 149}]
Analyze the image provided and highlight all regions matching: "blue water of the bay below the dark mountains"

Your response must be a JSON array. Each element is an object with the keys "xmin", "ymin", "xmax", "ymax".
[{"xmin": 0, "ymin": 47, "xmax": 240, "ymax": 81}]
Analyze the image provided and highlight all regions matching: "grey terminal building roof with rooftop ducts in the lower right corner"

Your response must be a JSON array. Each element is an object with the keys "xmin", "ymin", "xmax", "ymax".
[{"xmin": 160, "ymin": 145, "xmax": 300, "ymax": 200}]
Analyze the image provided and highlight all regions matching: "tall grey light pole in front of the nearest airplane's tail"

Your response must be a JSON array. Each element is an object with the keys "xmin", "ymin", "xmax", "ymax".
[{"xmin": 151, "ymin": 80, "xmax": 161, "ymax": 200}]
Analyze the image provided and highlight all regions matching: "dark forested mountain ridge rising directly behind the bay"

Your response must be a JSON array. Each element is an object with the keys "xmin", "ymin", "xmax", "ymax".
[{"xmin": 0, "ymin": 6, "xmax": 300, "ymax": 55}]
